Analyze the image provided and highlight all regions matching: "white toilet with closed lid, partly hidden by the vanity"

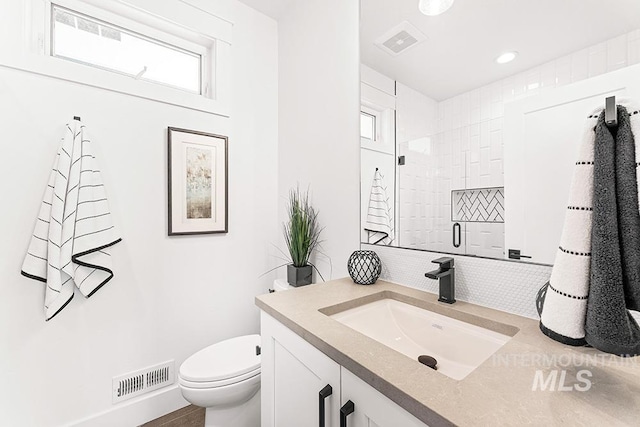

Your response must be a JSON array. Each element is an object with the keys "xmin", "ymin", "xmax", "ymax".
[{"xmin": 178, "ymin": 335, "xmax": 260, "ymax": 427}]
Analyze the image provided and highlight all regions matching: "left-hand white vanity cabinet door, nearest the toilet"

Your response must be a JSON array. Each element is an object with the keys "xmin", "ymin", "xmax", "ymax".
[{"xmin": 261, "ymin": 312, "xmax": 340, "ymax": 427}]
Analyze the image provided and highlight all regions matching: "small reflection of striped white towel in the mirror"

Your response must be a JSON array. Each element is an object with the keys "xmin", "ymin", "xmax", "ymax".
[{"xmin": 364, "ymin": 169, "xmax": 395, "ymax": 245}]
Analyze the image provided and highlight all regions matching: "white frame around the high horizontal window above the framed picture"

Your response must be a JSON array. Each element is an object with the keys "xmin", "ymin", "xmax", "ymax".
[{"xmin": 7, "ymin": 0, "xmax": 233, "ymax": 117}]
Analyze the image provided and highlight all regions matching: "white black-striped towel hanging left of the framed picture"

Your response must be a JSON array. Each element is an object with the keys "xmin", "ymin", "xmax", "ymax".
[{"xmin": 22, "ymin": 120, "xmax": 121, "ymax": 320}]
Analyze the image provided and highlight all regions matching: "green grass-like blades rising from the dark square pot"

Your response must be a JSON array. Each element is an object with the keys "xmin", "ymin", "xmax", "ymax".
[{"xmin": 284, "ymin": 187, "xmax": 322, "ymax": 267}]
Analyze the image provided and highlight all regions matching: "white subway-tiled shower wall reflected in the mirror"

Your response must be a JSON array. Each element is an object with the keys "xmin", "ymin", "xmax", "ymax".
[{"xmin": 397, "ymin": 30, "xmax": 640, "ymax": 258}]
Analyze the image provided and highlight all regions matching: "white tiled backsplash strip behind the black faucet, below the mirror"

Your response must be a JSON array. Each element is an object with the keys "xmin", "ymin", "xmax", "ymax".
[{"xmin": 362, "ymin": 244, "xmax": 551, "ymax": 319}]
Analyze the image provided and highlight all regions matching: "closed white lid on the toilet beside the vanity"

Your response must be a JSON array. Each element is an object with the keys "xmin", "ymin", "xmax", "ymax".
[{"xmin": 180, "ymin": 335, "xmax": 260, "ymax": 381}]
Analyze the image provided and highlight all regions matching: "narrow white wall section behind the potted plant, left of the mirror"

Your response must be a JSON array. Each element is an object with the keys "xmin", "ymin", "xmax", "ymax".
[{"xmin": 278, "ymin": 0, "xmax": 360, "ymax": 280}]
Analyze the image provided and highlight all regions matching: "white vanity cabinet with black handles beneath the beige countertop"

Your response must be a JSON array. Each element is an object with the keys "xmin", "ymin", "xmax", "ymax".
[{"xmin": 260, "ymin": 312, "xmax": 426, "ymax": 427}]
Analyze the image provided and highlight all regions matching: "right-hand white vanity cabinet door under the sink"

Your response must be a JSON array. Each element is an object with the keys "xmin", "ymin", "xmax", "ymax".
[{"xmin": 342, "ymin": 368, "xmax": 426, "ymax": 427}]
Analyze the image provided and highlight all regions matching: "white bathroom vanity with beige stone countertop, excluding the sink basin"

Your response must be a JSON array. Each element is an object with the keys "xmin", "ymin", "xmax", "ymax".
[{"xmin": 256, "ymin": 278, "xmax": 640, "ymax": 427}]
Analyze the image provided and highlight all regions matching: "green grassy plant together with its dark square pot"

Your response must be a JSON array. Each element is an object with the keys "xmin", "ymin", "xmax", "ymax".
[{"xmin": 284, "ymin": 187, "xmax": 322, "ymax": 286}]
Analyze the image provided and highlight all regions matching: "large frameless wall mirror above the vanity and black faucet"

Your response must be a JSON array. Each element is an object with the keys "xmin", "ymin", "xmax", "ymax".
[{"xmin": 360, "ymin": 0, "xmax": 640, "ymax": 264}]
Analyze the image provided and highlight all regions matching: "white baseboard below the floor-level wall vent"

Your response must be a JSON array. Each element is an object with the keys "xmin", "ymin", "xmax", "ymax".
[{"xmin": 70, "ymin": 384, "xmax": 189, "ymax": 427}]
